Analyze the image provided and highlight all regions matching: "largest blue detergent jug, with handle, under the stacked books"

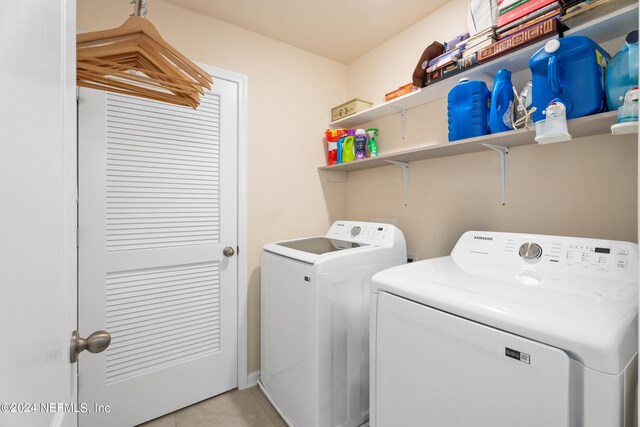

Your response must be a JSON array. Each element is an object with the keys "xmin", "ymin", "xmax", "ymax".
[{"xmin": 529, "ymin": 36, "xmax": 611, "ymax": 122}]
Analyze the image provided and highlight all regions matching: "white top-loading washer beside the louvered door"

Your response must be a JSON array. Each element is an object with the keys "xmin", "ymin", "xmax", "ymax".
[{"xmin": 258, "ymin": 221, "xmax": 407, "ymax": 427}]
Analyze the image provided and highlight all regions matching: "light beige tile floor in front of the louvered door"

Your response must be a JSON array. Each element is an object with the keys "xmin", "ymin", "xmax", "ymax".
[{"xmin": 138, "ymin": 386, "xmax": 287, "ymax": 427}]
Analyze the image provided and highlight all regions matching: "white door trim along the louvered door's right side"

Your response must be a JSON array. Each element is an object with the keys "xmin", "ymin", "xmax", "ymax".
[{"xmin": 198, "ymin": 63, "xmax": 250, "ymax": 390}]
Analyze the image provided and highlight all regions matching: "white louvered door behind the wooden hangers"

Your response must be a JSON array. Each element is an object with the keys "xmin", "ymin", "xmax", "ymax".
[{"xmin": 78, "ymin": 78, "xmax": 238, "ymax": 427}]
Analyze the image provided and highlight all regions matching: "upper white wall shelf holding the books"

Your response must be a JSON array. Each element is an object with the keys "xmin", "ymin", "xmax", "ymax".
[{"xmin": 330, "ymin": 3, "xmax": 638, "ymax": 129}]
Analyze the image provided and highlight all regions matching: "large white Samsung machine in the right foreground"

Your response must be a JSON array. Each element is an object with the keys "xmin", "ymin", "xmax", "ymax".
[{"xmin": 371, "ymin": 231, "xmax": 638, "ymax": 427}]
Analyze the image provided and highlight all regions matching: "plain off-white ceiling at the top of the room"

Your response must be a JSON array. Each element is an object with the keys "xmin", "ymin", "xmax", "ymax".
[{"xmin": 167, "ymin": 0, "xmax": 449, "ymax": 64}]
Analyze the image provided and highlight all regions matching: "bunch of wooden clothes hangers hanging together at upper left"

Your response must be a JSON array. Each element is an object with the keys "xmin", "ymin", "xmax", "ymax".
[{"xmin": 76, "ymin": 0, "xmax": 213, "ymax": 108}]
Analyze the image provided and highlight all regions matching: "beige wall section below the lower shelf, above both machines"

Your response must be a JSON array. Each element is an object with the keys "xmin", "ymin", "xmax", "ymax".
[{"xmin": 347, "ymin": 136, "xmax": 638, "ymax": 259}]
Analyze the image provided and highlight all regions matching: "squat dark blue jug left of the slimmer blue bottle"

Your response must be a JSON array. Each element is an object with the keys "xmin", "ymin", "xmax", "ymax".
[{"xmin": 447, "ymin": 78, "xmax": 491, "ymax": 141}]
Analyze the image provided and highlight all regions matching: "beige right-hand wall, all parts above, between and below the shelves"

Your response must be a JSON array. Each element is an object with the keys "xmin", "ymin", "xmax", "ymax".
[{"xmin": 346, "ymin": 0, "xmax": 638, "ymax": 259}]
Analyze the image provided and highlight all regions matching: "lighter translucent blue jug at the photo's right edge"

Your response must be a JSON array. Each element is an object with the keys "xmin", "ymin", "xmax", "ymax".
[{"xmin": 605, "ymin": 30, "xmax": 638, "ymax": 111}]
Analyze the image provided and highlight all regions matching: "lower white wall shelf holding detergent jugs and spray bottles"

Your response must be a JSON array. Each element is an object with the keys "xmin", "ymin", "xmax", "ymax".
[{"xmin": 318, "ymin": 111, "xmax": 618, "ymax": 172}]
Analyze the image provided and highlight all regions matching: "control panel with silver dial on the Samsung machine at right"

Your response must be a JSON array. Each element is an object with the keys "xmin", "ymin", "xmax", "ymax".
[{"xmin": 452, "ymin": 231, "xmax": 638, "ymax": 280}]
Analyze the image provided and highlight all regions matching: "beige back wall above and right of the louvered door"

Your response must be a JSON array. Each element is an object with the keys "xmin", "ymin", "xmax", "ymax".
[{"xmin": 78, "ymin": 0, "xmax": 347, "ymax": 372}]
